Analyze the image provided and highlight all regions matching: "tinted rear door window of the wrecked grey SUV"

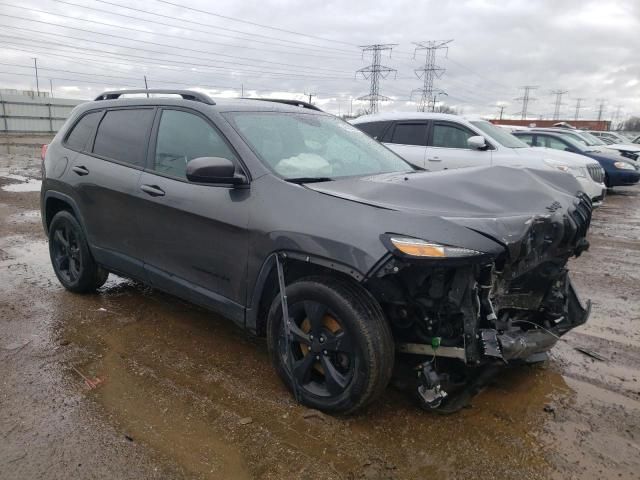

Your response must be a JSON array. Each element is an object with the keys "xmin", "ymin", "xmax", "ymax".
[{"xmin": 93, "ymin": 108, "xmax": 155, "ymax": 167}]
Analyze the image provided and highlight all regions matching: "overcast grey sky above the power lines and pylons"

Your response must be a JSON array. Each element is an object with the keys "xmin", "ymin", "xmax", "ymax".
[{"xmin": 0, "ymin": 0, "xmax": 640, "ymax": 119}]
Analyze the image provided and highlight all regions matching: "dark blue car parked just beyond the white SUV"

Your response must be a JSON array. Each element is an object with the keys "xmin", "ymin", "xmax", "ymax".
[{"xmin": 513, "ymin": 129, "xmax": 640, "ymax": 188}]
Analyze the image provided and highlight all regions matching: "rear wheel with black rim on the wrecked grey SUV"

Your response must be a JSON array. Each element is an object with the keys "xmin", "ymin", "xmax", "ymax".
[{"xmin": 49, "ymin": 210, "xmax": 109, "ymax": 293}]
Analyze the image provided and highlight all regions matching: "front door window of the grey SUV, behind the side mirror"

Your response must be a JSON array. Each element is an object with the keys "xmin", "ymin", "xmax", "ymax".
[{"xmin": 152, "ymin": 110, "xmax": 236, "ymax": 178}]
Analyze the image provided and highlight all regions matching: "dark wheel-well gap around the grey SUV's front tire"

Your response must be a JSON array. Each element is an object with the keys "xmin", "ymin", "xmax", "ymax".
[{"xmin": 256, "ymin": 258, "xmax": 364, "ymax": 337}]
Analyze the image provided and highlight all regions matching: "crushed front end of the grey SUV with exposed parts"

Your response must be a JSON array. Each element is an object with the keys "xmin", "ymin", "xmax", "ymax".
[{"xmin": 367, "ymin": 194, "xmax": 592, "ymax": 408}]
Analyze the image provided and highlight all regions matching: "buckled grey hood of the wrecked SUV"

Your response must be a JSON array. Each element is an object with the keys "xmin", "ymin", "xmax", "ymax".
[{"xmin": 306, "ymin": 166, "xmax": 580, "ymax": 218}]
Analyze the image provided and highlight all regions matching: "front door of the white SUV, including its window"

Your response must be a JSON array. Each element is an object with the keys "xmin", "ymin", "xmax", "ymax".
[{"xmin": 426, "ymin": 120, "xmax": 492, "ymax": 170}]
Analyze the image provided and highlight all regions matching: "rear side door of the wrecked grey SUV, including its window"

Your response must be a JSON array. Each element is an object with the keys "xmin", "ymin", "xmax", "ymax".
[{"xmin": 67, "ymin": 107, "xmax": 155, "ymax": 278}]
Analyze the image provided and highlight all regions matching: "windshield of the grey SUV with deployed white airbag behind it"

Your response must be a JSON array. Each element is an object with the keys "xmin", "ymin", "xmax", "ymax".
[{"xmin": 225, "ymin": 112, "xmax": 414, "ymax": 181}]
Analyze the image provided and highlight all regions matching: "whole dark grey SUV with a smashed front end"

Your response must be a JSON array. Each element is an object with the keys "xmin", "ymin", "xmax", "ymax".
[{"xmin": 41, "ymin": 90, "xmax": 591, "ymax": 412}]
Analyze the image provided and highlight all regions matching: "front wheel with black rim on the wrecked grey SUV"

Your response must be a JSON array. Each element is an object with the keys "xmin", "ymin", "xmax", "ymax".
[{"xmin": 267, "ymin": 276, "xmax": 394, "ymax": 413}]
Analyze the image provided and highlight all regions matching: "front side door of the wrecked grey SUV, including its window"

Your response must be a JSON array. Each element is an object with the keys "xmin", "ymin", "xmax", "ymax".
[{"xmin": 137, "ymin": 107, "xmax": 251, "ymax": 324}]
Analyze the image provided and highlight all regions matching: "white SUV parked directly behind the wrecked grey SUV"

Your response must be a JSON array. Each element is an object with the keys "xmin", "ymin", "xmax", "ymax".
[{"xmin": 351, "ymin": 112, "xmax": 606, "ymax": 205}]
